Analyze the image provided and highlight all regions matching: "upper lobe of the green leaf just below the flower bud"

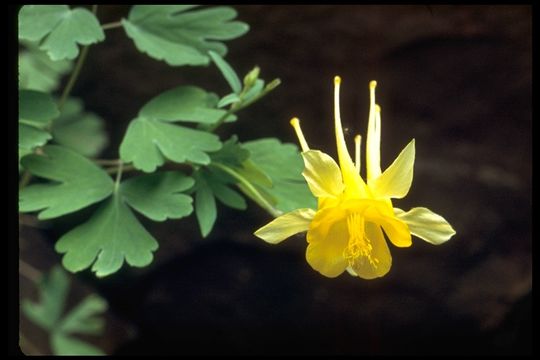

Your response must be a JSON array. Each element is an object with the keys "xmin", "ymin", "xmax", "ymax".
[{"xmin": 139, "ymin": 86, "xmax": 226, "ymax": 124}]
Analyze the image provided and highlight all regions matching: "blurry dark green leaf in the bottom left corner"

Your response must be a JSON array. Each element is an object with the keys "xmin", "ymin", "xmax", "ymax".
[{"xmin": 21, "ymin": 266, "xmax": 107, "ymax": 355}]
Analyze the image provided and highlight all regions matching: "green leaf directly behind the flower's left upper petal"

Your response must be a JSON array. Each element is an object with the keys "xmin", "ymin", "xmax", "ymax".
[{"xmin": 242, "ymin": 138, "xmax": 316, "ymax": 212}]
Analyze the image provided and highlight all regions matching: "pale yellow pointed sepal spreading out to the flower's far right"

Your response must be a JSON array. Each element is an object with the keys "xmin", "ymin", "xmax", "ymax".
[{"xmin": 394, "ymin": 207, "xmax": 456, "ymax": 245}]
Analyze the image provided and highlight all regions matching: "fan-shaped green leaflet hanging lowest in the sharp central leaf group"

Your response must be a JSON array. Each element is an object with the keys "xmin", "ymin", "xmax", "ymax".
[{"xmin": 55, "ymin": 193, "xmax": 158, "ymax": 277}]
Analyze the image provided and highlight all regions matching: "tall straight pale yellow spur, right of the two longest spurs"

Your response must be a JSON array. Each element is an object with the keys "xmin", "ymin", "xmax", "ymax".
[{"xmin": 366, "ymin": 81, "xmax": 381, "ymax": 183}]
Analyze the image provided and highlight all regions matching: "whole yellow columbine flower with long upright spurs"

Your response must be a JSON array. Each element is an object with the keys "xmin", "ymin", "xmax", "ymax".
[{"xmin": 255, "ymin": 76, "xmax": 455, "ymax": 279}]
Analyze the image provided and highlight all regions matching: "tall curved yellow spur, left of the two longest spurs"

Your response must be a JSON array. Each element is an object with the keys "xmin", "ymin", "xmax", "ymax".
[{"xmin": 334, "ymin": 76, "xmax": 368, "ymax": 197}]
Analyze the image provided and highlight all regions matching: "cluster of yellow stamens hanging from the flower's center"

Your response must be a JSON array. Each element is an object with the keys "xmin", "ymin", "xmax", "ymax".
[{"xmin": 343, "ymin": 212, "xmax": 379, "ymax": 268}]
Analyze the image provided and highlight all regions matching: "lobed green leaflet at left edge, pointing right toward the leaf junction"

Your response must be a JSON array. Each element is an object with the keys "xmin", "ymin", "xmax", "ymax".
[{"xmin": 19, "ymin": 145, "xmax": 113, "ymax": 219}]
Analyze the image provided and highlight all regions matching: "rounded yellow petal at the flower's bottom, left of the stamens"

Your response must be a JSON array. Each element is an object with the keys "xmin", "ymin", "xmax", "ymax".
[{"xmin": 306, "ymin": 209, "xmax": 349, "ymax": 278}]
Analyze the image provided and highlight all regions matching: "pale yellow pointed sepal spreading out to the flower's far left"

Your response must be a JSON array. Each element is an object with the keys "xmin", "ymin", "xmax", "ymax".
[{"xmin": 255, "ymin": 209, "xmax": 315, "ymax": 244}]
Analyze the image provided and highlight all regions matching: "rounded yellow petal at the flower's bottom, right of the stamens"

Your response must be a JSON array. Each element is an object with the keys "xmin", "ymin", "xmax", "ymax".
[{"xmin": 349, "ymin": 222, "xmax": 392, "ymax": 280}]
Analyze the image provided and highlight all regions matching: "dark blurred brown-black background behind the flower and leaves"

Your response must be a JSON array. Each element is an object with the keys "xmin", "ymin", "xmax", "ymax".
[{"xmin": 20, "ymin": 5, "xmax": 532, "ymax": 355}]
